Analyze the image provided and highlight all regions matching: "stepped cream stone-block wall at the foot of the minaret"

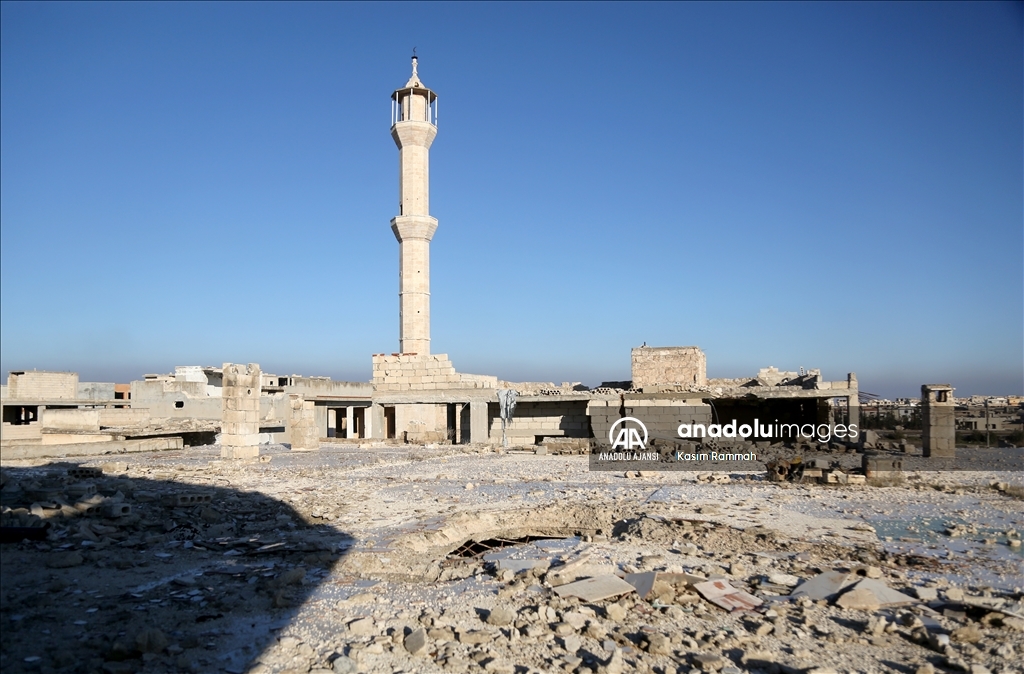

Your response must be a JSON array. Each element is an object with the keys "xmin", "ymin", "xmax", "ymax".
[{"xmin": 373, "ymin": 353, "xmax": 498, "ymax": 391}]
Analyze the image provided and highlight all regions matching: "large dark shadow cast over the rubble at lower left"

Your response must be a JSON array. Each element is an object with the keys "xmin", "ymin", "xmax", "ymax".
[{"xmin": 0, "ymin": 462, "xmax": 352, "ymax": 673}]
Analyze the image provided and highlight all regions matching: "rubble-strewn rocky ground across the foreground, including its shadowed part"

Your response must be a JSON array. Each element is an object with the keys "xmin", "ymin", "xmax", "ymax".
[{"xmin": 0, "ymin": 446, "xmax": 1024, "ymax": 674}]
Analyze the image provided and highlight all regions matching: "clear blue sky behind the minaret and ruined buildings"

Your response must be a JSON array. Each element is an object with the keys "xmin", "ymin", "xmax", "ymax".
[{"xmin": 0, "ymin": 2, "xmax": 1024, "ymax": 396}]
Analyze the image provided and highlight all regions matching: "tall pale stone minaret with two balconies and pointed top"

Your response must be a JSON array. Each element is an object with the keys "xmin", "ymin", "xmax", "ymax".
[{"xmin": 391, "ymin": 55, "xmax": 437, "ymax": 355}]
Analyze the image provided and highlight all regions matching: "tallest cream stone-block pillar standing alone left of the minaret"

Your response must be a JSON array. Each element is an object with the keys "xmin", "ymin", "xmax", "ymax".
[{"xmin": 220, "ymin": 363, "xmax": 261, "ymax": 459}]
